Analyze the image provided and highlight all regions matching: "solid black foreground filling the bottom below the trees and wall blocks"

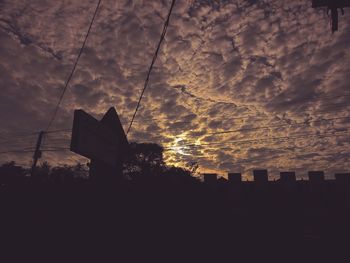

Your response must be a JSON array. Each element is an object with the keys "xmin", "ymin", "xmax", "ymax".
[{"xmin": 0, "ymin": 178, "xmax": 350, "ymax": 262}]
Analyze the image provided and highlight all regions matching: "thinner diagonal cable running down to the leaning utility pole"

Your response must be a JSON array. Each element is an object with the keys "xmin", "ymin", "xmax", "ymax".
[{"xmin": 45, "ymin": 0, "xmax": 102, "ymax": 132}]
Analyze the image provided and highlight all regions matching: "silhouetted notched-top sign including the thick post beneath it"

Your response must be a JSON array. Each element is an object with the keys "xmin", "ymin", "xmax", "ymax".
[{"xmin": 70, "ymin": 107, "xmax": 129, "ymax": 184}]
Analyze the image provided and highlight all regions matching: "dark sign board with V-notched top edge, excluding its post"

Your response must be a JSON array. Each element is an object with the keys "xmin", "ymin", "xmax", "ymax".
[{"xmin": 70, "ymin": 108, "xmax": 129, "ymax": 167}]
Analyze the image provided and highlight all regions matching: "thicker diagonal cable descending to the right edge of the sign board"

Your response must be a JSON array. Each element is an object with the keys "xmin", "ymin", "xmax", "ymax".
[{"xmin": 126, "ymin": 0, "xmax": 176, "ymax": 134}]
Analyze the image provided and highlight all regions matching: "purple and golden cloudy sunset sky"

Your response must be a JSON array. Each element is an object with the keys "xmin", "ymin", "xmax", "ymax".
[{"xmin": 0, "ymin": 0, "xmax": 350, "ymax": 178}]
